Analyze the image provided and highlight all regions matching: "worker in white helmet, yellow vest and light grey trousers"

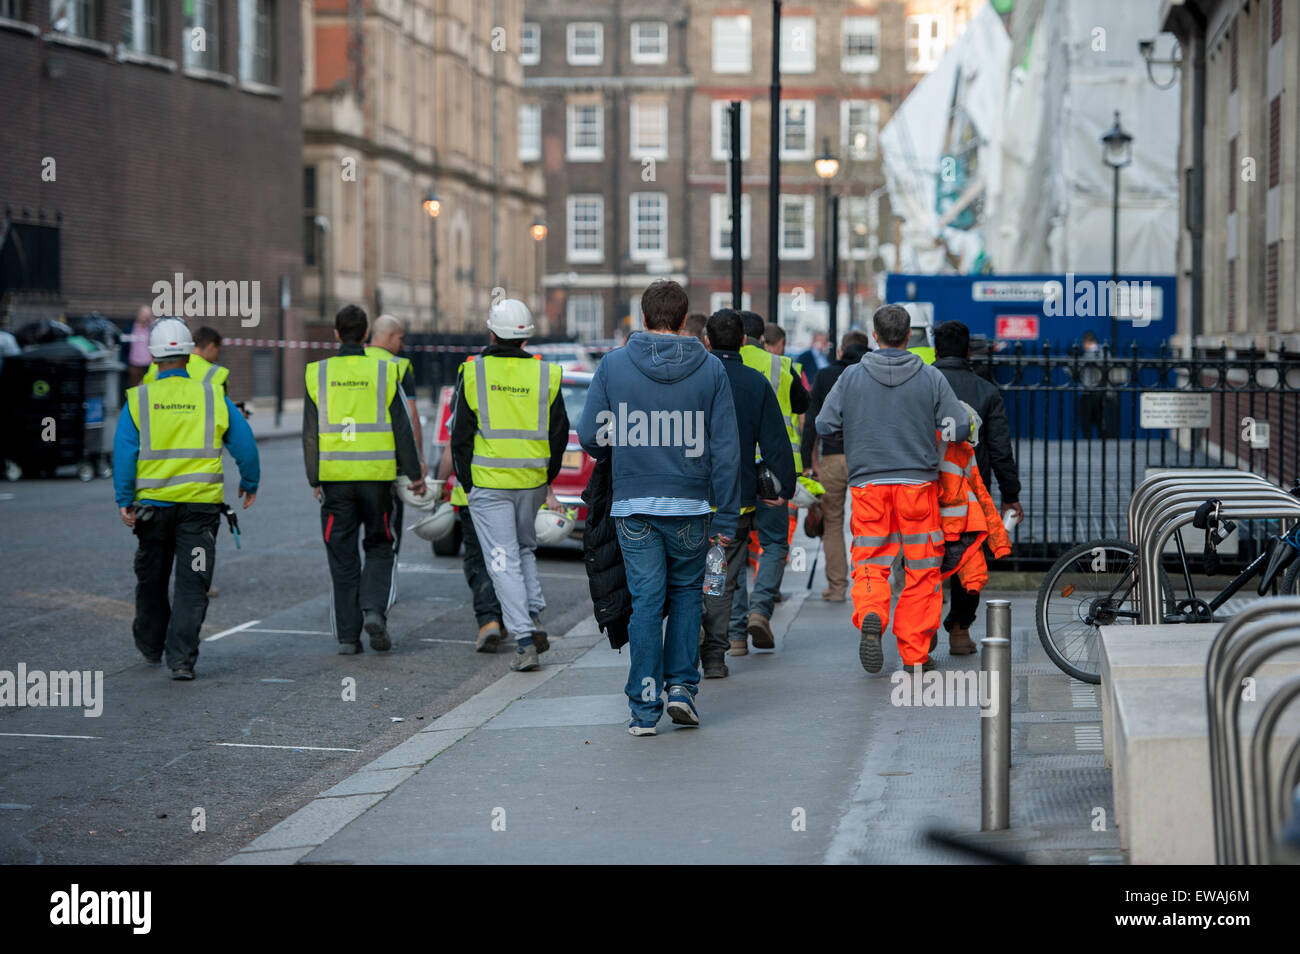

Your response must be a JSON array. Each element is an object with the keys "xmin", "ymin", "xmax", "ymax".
[{"xmin": 451, "ymin": 298, "xmax": 569, "ymax": 672}]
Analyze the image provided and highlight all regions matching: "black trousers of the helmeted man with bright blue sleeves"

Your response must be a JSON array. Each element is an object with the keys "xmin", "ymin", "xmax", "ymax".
[{"xmin": 131, "ymin": 503, "xmax": 221, "ymax": 669}]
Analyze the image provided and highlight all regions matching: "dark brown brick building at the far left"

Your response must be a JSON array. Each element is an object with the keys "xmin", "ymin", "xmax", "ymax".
[{"xmin": 0, "ymin": 0, "xmax": 303, "ymax": 399}]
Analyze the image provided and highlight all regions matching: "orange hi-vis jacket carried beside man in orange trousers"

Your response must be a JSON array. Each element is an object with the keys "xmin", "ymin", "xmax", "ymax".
[{"xmin": 939, "ymin": 441, "xmax": 1011, "ymax": 593}]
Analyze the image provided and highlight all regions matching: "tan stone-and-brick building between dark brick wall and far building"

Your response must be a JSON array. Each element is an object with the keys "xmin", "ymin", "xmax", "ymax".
[{"xmin": 302, "ymin": 0, "xmax": 545, "ymax": 333}]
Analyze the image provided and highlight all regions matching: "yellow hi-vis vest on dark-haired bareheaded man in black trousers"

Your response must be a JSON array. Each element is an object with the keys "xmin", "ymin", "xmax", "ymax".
[{"xmin": 307, "ymin": 355, "xmax": 398, "ymax": 481}]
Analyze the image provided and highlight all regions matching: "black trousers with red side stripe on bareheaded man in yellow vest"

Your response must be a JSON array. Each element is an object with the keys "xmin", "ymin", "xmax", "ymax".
[{"xmin": 321, "ymin": 481, "xmax": 395, "ymax": 642}]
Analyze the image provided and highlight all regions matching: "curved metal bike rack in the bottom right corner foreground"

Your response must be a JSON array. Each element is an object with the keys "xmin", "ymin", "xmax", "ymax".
[{"xmin": 1205, "ymin": 597, "xmax": 1300, "ymax": 864}]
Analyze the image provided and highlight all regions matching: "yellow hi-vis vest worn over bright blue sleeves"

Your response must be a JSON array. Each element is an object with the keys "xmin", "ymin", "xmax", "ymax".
[{"xmin": 126, "ymin": 374, "xmax": 230, "ymax": 503}]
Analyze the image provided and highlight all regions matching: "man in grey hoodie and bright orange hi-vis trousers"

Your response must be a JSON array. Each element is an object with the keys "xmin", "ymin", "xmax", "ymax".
[{"xmin": 816, "ymin": 304, "xmax": 970, "ymax": 672}]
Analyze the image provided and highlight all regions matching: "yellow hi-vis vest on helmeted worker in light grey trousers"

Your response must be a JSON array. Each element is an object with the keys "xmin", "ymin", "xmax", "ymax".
[{"xmin": 462, "ymin": 355, "xmax": 560, "ymax": 490}]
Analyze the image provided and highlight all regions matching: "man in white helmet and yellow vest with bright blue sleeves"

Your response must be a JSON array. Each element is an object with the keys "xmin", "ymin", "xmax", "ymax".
[{"xmin": 113, "ymin": 317, "xmax": 261, "ymax": 680}]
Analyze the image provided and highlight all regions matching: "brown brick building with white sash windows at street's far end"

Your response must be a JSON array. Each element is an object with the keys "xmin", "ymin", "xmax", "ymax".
[{"xmin": 520, "ymin": 0, "xmax": 974, "ymax": 338}]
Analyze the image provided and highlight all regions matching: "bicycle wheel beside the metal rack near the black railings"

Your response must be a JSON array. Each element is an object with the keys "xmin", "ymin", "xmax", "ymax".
[{"xmin": 1035, "ymin": 539, "xmax": 1173, "ymax": 685}]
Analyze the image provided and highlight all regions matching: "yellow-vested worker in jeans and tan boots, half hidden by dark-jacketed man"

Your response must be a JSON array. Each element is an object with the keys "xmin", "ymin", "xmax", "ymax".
[{"xmin": 727, "ymin": 312, "xmax": 809, "ymax": 655}]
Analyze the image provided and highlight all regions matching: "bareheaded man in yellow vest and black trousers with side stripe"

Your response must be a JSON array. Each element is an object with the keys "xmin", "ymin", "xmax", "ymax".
[{"xmin": 303, "ymin": 304, "xmax": 424, "ymax": 655}]
